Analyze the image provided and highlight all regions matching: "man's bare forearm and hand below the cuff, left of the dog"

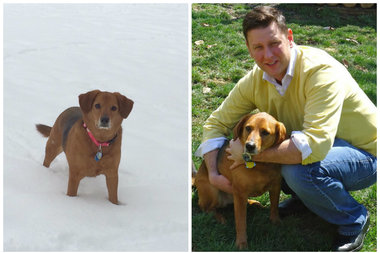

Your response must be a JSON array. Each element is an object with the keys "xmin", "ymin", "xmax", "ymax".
[{"xmin": 203, "ymin": 149, "xmax": 232, "ymax": 194}]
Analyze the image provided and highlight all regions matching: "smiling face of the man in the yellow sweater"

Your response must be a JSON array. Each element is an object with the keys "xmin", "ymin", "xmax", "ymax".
[{"xmin": 246, "ymin": 22, "xmax": 293, "ymax": 81}]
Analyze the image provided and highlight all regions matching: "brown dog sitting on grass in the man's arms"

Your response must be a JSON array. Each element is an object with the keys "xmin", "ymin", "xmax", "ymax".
[{"xmin": 195, "ymin": 113, "xmax": 286, "ymax": 249}]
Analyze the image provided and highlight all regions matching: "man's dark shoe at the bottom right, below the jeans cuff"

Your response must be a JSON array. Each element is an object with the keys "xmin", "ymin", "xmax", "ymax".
[{"xmin": 333, "ymin": 214, "xmax": 369, "ymax": 251}]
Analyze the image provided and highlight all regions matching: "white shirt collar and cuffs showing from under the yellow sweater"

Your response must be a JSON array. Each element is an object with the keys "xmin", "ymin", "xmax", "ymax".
[{"xmin": 194, "ymin": 42, "xmax": 312, "ymax": 160}]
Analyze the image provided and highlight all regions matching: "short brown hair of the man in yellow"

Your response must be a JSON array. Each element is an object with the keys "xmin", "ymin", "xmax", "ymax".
[{"xmin": 243, "ymin": 5, "xmax": 288, "ymax": 39}]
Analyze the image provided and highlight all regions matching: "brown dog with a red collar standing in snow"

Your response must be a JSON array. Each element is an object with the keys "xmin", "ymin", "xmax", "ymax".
[{"xmin": 36, "ymin": 90, "xmax": 133, "ymax": 204}]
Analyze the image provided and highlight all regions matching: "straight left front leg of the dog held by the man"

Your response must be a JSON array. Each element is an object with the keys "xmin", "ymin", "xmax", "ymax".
[{"xmin": 233, "ymin": 190, "xmax": 248, "ymax": 250}]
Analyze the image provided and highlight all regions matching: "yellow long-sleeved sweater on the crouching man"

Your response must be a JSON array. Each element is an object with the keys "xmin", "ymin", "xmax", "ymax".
[{"xmin": 203, "ymin": 46, "xmax": 377, "ymax": 164}]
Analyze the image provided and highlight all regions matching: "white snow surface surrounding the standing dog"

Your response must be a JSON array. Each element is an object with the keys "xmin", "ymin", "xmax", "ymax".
[{"xmin": 3, "ymin": 4, "xmax": 189, "ymax": 251}]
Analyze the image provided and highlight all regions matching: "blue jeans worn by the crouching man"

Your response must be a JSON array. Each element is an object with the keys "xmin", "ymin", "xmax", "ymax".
[{"xmin": 282, "ymin": 139, "xmax": 377, "ymax": 236}]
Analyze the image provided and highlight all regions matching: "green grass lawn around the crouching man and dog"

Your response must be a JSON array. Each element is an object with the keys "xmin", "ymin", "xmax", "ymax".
[{"xmin": 192, "ymin": 4, "xmax": 377, "ymax": 251}]
